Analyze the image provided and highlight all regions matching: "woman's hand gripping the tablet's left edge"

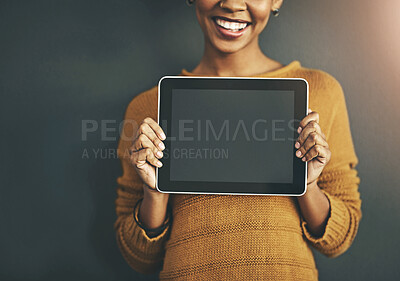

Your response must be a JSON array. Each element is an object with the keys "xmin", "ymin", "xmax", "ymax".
[{"xmin": 129, "ymin": 117, "xmax": 167, "ymax": 196}]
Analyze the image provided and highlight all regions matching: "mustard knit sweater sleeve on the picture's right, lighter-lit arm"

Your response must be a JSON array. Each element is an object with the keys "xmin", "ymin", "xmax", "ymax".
[{"xmin": 301, "ymin": 76, "xmax": 361, "ymax": 257}]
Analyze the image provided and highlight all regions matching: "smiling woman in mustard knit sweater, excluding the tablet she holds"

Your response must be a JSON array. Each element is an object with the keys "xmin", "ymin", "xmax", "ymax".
[{"xmin": 115, "ymin": 0, "xmax": 361, "ymax": 280}]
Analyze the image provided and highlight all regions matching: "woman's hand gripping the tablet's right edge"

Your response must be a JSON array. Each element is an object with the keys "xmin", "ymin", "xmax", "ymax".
[{"xmin": 295, "ymin": 109, "xmax": 331, "ymax": 185}]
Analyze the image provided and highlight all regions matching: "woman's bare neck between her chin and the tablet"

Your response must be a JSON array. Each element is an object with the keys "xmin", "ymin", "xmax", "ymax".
[{"xmin": 192, "ymin": 39, "xmax": 282, "ymax": 76}]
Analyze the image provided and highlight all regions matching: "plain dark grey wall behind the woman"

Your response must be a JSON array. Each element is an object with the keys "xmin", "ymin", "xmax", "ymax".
[{"xmin": 0, "ymin": 0, "xmax": 400, "ymax": 280}]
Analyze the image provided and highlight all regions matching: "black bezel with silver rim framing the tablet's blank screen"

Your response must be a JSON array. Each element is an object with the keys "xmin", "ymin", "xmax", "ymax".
[{"xmin": 156, "ymin": 75, "xmax": 309, "ymax": 196}]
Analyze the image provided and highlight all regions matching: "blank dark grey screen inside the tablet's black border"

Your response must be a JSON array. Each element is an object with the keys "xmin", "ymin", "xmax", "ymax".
[{"xmin": 169, "ymin": 89, "xmax": 295, "ymax": 183}]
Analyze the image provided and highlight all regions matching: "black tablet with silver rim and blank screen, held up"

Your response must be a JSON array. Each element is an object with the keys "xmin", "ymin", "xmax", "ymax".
[{"xmin": 156, "ymin": 76, "xmax": 308, "ymax": 196}]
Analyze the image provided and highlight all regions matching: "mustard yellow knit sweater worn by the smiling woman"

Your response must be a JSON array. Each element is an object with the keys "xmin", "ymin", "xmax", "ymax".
[{"xmin": 115, "ymin": 61, "xmax": 361, "ymax": 281}]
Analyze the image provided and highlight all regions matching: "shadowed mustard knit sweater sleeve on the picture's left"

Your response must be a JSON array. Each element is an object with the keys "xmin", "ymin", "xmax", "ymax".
[{"xmin": 114, "ymin": 91, "xmax": 170, "ymax": 273}]
